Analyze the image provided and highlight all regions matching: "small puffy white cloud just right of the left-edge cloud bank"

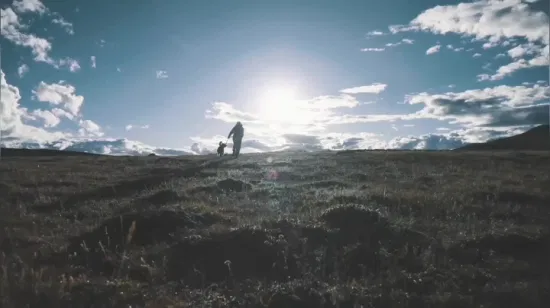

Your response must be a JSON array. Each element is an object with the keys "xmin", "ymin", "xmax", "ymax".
[{"xmin": 32, "ymin": 81, "xmax": 84, "ymax": 116}]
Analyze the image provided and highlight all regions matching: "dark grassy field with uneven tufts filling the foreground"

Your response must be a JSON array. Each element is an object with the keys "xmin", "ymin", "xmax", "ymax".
[{"xmin": 0, "ymin": 151, "xmax": 550, "ymax": 308}]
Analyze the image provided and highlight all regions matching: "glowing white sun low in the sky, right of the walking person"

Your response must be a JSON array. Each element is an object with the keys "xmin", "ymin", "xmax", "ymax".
[{"xmin": 258, "ymin": 86, "xmax": 306, "ymax": 124}]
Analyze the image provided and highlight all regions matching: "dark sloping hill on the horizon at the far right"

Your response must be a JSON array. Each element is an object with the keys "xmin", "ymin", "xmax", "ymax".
[{"xmin": 457, "ymin": 125, "xmax": 550, "ymax": 151}]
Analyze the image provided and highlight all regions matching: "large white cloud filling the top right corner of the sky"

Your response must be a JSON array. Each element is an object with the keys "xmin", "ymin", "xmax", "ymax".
[{"xmin": 390, "ymin": 0, "xmax": 550, "ymax": 81}]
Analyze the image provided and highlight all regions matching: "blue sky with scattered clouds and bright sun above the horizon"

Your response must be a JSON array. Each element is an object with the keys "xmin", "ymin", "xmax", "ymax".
[{"xmin": 0, "ymin": 0, "xmax": 550, "ymax": 155}]
